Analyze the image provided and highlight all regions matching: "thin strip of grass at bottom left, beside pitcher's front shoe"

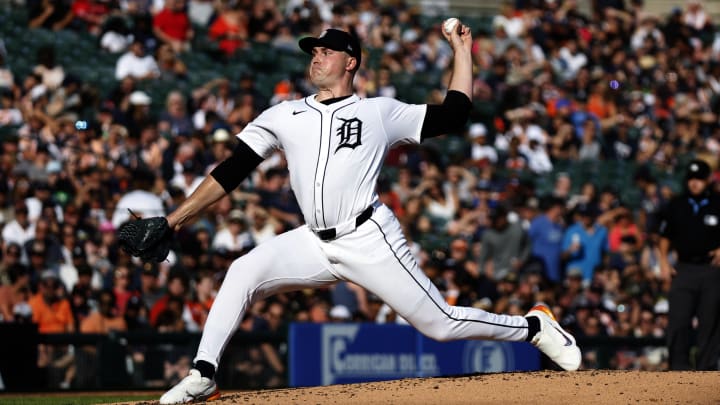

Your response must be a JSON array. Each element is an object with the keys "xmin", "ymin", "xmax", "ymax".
[{"xmin": 0, "ymin": 393, "xmax": 159, "ymax": 405}]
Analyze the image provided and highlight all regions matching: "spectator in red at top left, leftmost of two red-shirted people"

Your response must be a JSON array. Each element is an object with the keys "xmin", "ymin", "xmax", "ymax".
[{"xmin": 153, "ymin": 0, "xmax": 195, "ymax": 52}]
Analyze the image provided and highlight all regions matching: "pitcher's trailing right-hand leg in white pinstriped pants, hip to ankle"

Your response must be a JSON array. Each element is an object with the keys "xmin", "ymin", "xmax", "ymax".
[{"xmin": 336, "ymin": 207, "xmax": 528, "ymax": 341}]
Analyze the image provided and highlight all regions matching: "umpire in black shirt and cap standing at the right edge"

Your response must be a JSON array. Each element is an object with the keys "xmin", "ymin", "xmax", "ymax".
[{"xmin": 660, "ymin": 160, "xmax": 720, "ymax": 370}]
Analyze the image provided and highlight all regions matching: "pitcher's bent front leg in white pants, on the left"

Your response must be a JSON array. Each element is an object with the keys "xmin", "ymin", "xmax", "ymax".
[{"xmin": 195, "ymin": 227, "xmax": 337, "ymax": 368}]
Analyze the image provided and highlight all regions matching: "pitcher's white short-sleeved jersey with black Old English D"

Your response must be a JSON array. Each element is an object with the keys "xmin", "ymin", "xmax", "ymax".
[{"xmin": 238, "ymin": 95, "xmax": 427, "ymax": 229}]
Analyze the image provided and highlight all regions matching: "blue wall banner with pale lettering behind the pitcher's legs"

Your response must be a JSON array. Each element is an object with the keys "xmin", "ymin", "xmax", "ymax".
[{"xmin": 288, "ymin": 323, "xmax": 540, "ymax": 387}]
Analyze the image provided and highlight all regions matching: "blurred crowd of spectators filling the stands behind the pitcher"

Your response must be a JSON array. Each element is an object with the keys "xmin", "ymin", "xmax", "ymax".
[{"xmin": 0, "ymin": 0, "xmax": 720, "ymax": 387}]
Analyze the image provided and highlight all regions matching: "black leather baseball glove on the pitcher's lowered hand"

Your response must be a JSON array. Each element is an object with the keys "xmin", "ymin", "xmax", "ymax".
[{"xmin": 117, "ymin": 217, "xmax": 173, "ymax": 263}]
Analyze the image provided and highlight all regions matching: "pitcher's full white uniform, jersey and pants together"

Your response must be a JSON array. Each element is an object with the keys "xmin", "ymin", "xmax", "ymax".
[{"xmin": 195, "ymin": 95, "xmax": 528, "ymax": 367}]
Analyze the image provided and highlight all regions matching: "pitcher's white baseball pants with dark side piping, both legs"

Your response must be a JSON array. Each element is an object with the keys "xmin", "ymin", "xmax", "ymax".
[{"xmin": 195, "ymin": 205, "xmax": 527, "ymax": 367}]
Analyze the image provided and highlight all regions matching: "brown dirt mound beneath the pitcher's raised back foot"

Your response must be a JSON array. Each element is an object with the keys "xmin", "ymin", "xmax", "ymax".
[{"xmin": 122, "ymin": 370, "xmax": 720, "ymax": 405}]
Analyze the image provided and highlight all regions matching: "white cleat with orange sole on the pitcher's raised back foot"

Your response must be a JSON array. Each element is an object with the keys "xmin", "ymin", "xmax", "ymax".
[{"xmin": 525, "ymin": 304, "xmax": 582, "ymax": 371}]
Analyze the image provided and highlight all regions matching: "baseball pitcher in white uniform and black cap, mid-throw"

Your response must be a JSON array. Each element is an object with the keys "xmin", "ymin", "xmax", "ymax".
[{"xmin": 120, "ymin": 22, "xmax": 581, "ymax": 404}]
